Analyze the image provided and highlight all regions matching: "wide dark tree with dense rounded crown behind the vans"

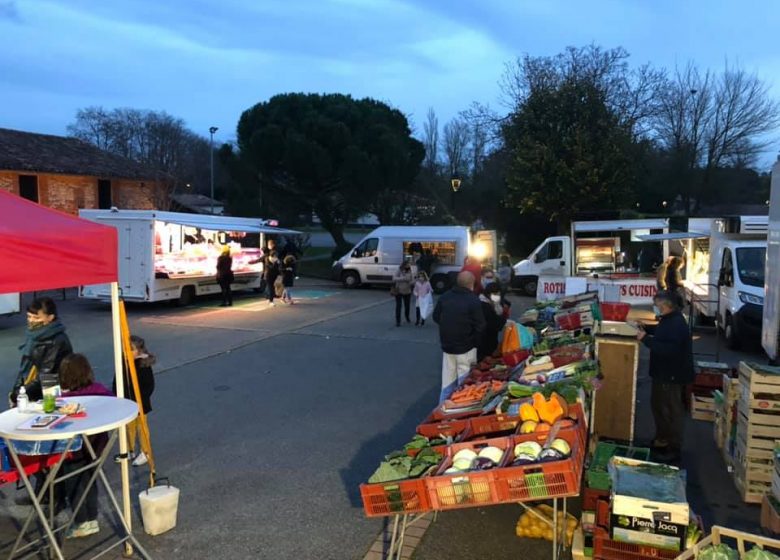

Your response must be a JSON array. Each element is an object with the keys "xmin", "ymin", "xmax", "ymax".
[{"xmin": 223, "ymin": 93, "xmax": 425, "ymax": 249}]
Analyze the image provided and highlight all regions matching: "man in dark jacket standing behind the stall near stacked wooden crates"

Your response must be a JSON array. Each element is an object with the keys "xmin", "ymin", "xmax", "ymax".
[{"xmin": 637, "ymin": 291, "xmax": 694, "ymax": 462}]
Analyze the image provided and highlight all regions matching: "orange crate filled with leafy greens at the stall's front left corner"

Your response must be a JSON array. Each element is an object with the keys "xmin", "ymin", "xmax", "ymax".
[{"xmin": 360, "ymin": 440, "xmax": 443, "ymax": 517}]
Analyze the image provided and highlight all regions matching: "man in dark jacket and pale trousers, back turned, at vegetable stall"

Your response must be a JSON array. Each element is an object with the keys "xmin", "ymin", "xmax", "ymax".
[{"xmin": 433, "ymin": 271, "xmax": 485, "ymax": 402}]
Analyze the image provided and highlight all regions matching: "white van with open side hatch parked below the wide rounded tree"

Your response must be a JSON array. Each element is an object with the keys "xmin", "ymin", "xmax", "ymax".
[{"xmin": 333, "ymin": 226, "xmax": 497, "ymax": 293}]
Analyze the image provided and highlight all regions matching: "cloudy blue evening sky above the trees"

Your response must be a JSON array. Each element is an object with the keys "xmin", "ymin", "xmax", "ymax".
[{"xmin": 0, "ymin": 0, "xmax": 780, "ymax": 167}]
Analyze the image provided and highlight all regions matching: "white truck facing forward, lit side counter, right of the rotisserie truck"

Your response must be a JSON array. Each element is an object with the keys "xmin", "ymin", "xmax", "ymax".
[{"xmin": 683, "ymin": 216, "xmax": 769, "ymax": 348}]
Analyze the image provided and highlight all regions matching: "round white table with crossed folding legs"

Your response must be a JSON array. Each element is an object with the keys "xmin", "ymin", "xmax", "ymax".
[{"xmin": 0, "ymin": 397, "xmax": 151, "ymax": 560}]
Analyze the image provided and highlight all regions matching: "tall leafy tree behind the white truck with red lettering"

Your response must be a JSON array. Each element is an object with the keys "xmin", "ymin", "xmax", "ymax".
[{"xmin": 502, "ymin": 46, "xmax": 663, "ymax": 230}]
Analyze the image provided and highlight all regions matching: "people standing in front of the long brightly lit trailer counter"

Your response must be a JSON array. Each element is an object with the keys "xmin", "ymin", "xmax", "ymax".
[{"xmin": 217, "ymin": 239, "xmax": 297, "ymax": 307}]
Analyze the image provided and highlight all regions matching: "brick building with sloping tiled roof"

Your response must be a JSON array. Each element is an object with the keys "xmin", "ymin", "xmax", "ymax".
[{"xmin": 0, "ymin": 128, "xmax": 167, "ymax": 214}]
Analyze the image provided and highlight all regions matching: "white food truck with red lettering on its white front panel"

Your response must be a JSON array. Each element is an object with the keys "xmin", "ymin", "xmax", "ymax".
[{"xmin": 513, "ymin": 218, "xmax": 669, "ymax": 304}]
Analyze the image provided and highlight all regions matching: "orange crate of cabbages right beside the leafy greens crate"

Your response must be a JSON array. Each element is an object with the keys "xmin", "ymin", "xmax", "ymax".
[{"xmin": 425, "ymin": 438, "xmax": 512, "ymax": 511}]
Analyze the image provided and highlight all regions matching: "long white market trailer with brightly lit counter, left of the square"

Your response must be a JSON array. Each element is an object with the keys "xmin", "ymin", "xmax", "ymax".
[{"xmin": 79, "ymin": 209, "xmax": 298, "ymax": 305}]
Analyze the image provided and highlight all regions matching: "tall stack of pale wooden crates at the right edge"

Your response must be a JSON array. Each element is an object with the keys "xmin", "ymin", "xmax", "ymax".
[{"xmin": 734, "ymin": 362, "xmax": 780, "ymax": 503}]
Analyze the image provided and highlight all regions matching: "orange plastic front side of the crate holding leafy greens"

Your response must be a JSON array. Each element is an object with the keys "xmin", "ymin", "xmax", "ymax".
[{"xmin": 360, "ymin": 477, "xmax": 431, "ymax": 517}]
